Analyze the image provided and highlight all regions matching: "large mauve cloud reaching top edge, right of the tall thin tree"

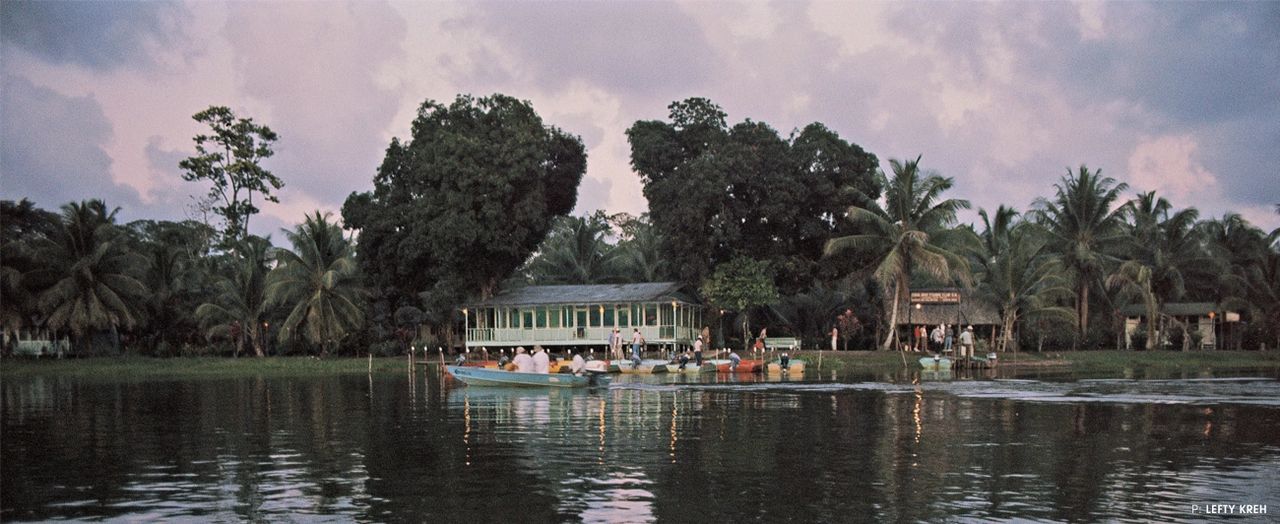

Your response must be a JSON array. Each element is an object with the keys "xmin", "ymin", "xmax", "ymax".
[{"xmin": 224, "ymin": 3, "xmax": 407, "ymax": 219}]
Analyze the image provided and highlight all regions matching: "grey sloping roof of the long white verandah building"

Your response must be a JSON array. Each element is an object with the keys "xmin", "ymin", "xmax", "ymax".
[{"xmin": 476, "ymin": 282, "xmax": 700, "ymax": 306}]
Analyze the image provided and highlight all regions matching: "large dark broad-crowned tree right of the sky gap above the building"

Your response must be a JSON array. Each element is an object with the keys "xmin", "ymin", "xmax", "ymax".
[{"xmin": 627, "ymin": 99, "xmax": 879, "ymax": 293}]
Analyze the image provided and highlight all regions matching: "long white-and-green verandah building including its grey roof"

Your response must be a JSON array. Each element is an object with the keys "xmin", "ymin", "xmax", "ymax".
[{"xmin": 467, "ymin": 282, "xmax": 703, "ymax": 347}]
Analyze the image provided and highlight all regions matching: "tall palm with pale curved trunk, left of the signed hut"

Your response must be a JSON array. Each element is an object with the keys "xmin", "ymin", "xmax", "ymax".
[{"xmin": 824, "ymin": 156, "xmax": 969, "ymax": 350}]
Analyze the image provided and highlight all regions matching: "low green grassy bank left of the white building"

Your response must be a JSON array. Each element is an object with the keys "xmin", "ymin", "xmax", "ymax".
[{"xmin": 0, "ymin": 356, "xmax": 419, "ymax": 378}]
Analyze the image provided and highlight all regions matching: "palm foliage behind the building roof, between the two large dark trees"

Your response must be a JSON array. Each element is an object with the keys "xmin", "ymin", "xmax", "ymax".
[{"xmin": 529, "ymin": 211, "xmax": 622, "ymax": 284}]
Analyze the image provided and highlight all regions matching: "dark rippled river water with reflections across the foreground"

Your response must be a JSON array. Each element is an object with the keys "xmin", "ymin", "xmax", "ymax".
[{"xmin": 0, "ymin": 372, "xmax": 1280, "ymax": 523}]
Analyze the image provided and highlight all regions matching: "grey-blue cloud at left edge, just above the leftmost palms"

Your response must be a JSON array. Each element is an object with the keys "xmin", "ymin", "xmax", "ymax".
[{"xmin": 0, "ymin": 74, "xmax": 141, "ymax": 209}]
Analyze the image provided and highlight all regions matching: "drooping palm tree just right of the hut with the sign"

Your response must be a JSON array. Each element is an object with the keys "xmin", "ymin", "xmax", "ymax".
[{"xmin": 974, "ymin": 206, "xmax": 1074, "ymax": 351}]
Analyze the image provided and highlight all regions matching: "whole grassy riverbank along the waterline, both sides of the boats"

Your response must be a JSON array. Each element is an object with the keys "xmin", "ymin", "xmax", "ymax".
[{"xmin": 0, "ymin": 351, "xmax": 1280, "ymax": 378}]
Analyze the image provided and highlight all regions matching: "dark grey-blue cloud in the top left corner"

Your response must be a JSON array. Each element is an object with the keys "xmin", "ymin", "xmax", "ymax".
[{"xmin": 0, "ymin": 1, "xmax": 189, "ymax": 70}]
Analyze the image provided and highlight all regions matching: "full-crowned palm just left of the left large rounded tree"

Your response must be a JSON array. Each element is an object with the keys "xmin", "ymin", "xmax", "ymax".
[{"xmin": 266, "ymin": 211, "xmax": 365, "ymax": 355}]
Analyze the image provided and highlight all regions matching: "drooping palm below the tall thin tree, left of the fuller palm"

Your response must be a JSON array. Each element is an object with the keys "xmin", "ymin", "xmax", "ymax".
[{"xmin": 196, "ymin": 236, "xmax": 271, "ymax": 357}]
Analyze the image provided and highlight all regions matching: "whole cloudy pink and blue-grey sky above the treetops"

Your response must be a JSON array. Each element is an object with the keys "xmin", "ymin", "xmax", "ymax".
[{"xmin": 0, "ymin": 1, "xmax": 1280, "ymax": 237}]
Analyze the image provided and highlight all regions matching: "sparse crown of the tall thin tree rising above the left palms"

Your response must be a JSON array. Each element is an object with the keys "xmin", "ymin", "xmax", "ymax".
[{"xmin": 178, "ymin": 105, "xmax": 284, "ymax": 243}]
